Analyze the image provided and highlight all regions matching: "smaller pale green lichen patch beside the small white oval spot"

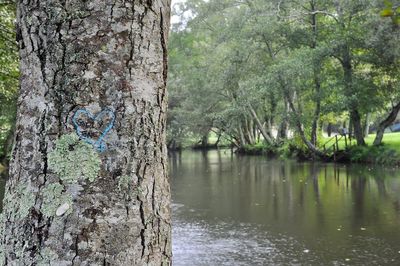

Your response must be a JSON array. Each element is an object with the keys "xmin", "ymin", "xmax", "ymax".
[{"xmin": 41, "ymin": 183, "xmax": 72, "ymax": 217}]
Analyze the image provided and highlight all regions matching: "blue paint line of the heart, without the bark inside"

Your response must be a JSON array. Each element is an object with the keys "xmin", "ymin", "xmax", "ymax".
[{"xmin": 72, "ymin": 109, "xmax": 115, "ymax": 152}]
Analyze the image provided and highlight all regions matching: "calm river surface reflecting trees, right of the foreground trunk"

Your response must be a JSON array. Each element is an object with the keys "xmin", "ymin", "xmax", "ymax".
[{"xmin": 170, "ymin": 151, "xmax": 400, "ymax": 265}]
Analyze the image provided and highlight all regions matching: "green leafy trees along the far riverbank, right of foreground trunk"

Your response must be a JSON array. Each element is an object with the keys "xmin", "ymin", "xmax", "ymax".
[{"xmin": 168, "ymin": 0, "xmax": 400, "ymax": 154}]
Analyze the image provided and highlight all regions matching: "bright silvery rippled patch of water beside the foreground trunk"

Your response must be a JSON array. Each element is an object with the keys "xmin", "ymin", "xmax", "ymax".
[{"xmin": 172, "ymin": 217, "xmax": 318, "ymax": 265}]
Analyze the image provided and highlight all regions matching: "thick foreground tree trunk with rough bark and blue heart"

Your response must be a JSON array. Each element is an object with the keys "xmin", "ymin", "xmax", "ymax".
[{"xmin": 0, "ymin": 0, "xmax": 171, "ymax": 265}]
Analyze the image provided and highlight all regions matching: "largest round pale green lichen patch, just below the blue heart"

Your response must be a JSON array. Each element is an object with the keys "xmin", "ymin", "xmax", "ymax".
[{"xmin": 48, "ymin": 133, "xmax": 101, "ymax": 183}]
